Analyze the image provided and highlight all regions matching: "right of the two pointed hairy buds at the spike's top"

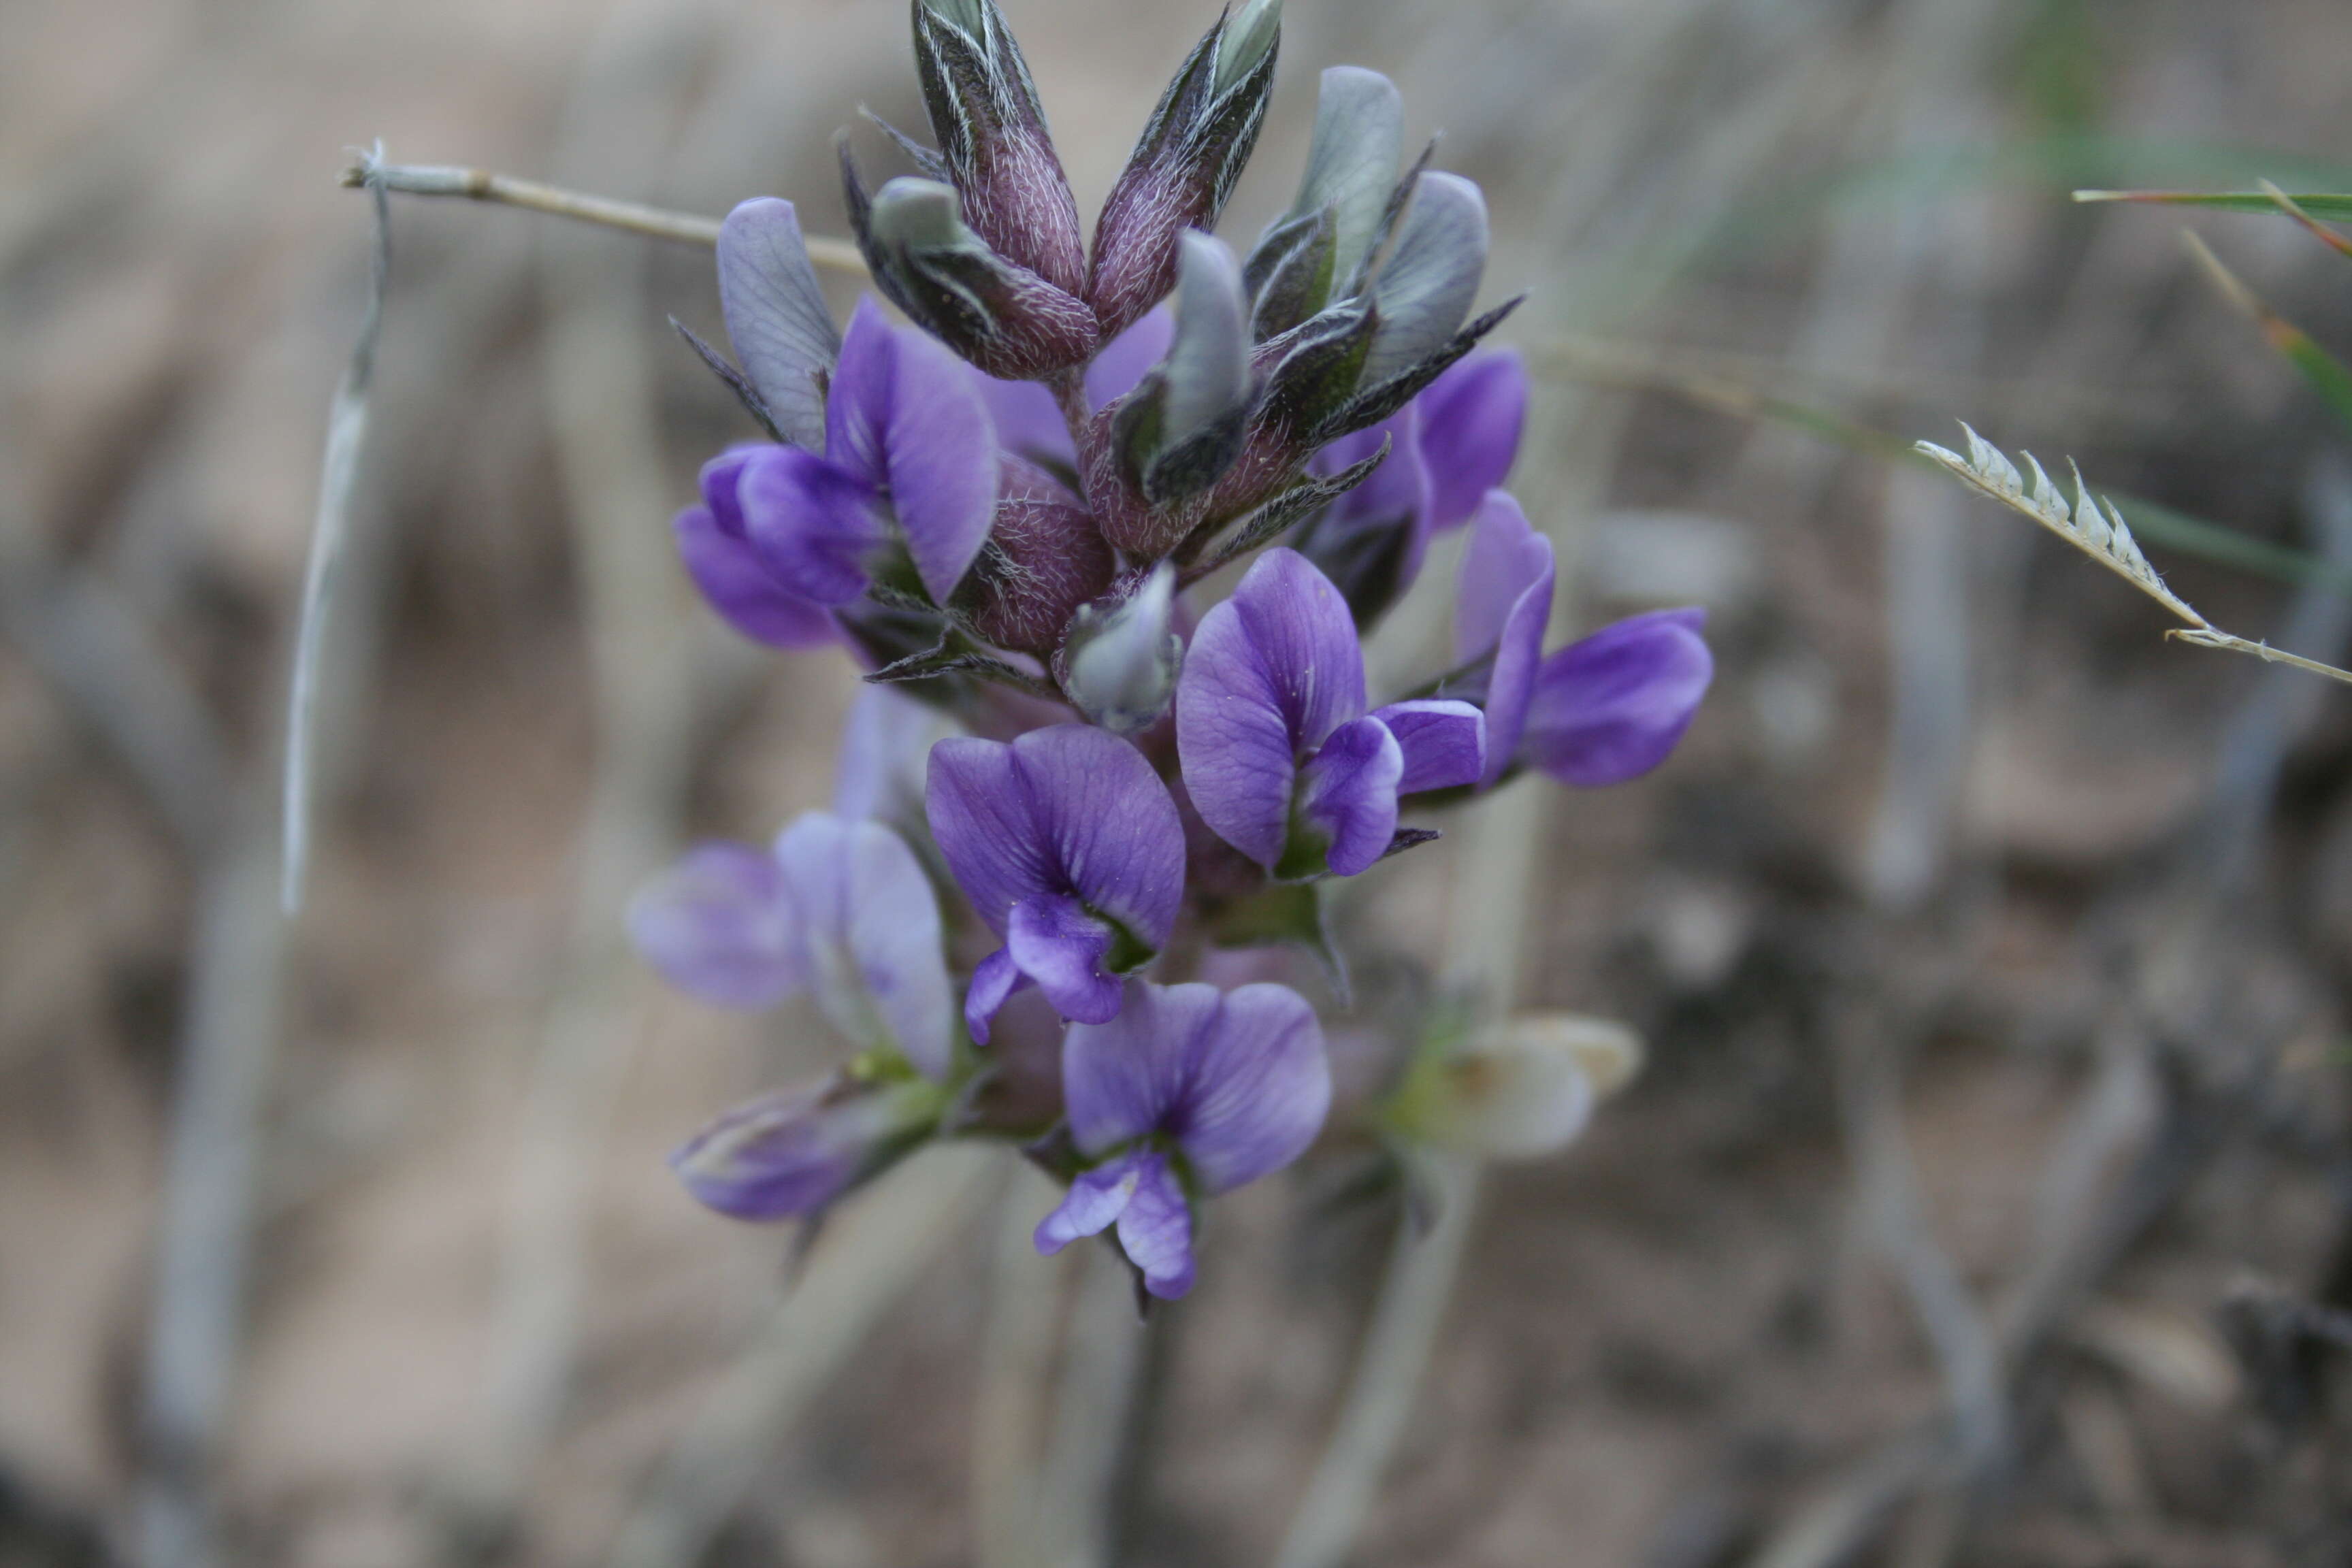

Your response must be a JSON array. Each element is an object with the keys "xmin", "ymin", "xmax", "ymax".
[{"xmin": 1087, "ymin": 0, "xmax": 1282, "ymax": 336}]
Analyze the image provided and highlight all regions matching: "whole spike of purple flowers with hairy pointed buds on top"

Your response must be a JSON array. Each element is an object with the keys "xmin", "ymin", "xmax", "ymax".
[{"xmin": 633, "ymin": 0, "xmax": 1712, "ymax": 1295}]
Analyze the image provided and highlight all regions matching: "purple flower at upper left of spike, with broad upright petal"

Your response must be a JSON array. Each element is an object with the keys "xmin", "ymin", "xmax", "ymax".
[{"xmin": 698, "ymin": 301, "xmax": 997, "ymax": 606}]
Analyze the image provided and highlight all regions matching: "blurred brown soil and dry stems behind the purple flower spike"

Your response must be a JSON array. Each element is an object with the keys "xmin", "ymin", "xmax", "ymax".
[{"xmin": 0, "ymin": 0, "xmax": 2352, "ymax": 1568}]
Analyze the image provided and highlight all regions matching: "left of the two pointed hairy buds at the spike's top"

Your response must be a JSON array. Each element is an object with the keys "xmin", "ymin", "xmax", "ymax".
[{"xmin": 915, "ymin": 0, "xmax": 1087, "ymax": 294}]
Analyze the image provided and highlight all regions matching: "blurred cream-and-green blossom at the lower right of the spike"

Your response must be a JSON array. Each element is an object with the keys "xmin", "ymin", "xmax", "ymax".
[{"xmin": 1388, "ymin": 1013, "xmax": 1642, "ymax": 1159}]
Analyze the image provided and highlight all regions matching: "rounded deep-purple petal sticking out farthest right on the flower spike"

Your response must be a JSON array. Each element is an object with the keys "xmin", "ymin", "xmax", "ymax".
[{"xmin": 1524, "ymin": 609, "xmax": 1714, "ymax": 790}]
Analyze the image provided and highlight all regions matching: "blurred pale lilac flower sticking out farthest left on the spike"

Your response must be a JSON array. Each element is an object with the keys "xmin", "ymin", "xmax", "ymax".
[{"xmin": 630, "ymin": 811, "xmax": 955, "ymax": 1079}]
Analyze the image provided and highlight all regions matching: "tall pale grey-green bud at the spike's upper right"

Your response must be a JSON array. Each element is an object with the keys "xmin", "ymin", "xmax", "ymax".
[{"xmin": 1247, "ymin": 66, "xmax": 1404, "ymax": 338}]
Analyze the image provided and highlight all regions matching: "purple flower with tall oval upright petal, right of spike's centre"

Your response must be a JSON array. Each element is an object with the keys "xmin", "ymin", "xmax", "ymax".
[{"xmin": 1176, "ymin": 550, "xmax": 1486, "ymax": 879}]
